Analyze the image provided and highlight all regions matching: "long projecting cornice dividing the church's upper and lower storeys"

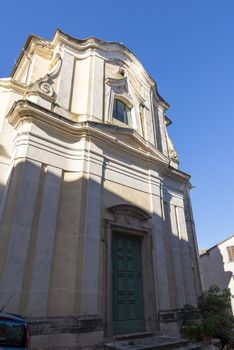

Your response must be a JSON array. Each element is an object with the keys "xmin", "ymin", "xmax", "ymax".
[{"xmin": 7, "ymin": 100, "xmax": 190, "ymax": 182}]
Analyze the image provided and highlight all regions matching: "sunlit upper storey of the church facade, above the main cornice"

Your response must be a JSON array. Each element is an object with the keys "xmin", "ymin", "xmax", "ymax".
[{"xmin": 0, "ymin": 29, "xmax": 189, "ymax": 181}]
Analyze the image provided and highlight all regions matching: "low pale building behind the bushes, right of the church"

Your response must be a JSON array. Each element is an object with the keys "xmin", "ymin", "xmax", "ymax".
[{"xmin": 200, "ymin": 235, "xmax": 234, "ymax": 314}]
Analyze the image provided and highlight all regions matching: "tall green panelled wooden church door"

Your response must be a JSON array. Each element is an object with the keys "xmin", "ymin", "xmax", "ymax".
[{"xmin": 113, "ymin": 233, "xmax": 144, "ymax": 334}]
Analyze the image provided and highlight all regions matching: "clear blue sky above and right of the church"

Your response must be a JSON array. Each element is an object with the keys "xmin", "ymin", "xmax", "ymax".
[{"xmin": 0, "ymin": 0, "xmax": 234, "ymax": 248}]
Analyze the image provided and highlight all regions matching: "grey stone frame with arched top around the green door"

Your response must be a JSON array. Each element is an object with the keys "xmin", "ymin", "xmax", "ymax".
[{"xmin": 103, "ymin": 204, "xmax": 159, "ymax": 338}]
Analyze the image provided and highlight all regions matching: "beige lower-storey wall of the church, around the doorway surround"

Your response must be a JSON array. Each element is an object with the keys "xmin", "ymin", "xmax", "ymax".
[{"xmin": 1, "ymin": 126, "xmax": 201, "ymax": 315}]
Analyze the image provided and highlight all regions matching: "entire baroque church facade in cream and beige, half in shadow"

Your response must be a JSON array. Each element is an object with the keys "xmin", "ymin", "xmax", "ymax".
[{"xmin": 0, "ymin": 30, "xmax": 201, "ymax": 348}]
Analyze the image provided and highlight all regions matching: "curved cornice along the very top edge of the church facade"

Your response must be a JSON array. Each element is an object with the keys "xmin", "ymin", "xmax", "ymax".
[{"xmin": 10, "ymin": 29, "xmax": 170, "ymax": 110}]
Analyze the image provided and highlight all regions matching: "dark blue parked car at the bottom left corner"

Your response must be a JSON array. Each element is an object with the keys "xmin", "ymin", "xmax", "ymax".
[{"xmin": 0, "ymin": 312, "xmax": 29, "ymax": 350}]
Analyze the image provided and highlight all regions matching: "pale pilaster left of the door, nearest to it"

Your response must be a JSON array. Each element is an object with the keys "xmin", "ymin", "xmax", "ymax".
[{"xmin": 81, "ymin": 141, "xmax": 104, "ymax": 314}]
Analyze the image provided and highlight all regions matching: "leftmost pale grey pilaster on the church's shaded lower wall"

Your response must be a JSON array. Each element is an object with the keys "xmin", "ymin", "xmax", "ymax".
[{"xmin": 0, "ymin": 160, "xmax": 40, "ymax": 312}]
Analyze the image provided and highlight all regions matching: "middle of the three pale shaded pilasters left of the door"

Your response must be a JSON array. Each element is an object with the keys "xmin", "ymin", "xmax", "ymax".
[{"xmin": 27, "ymin": 166, "xmax": 61, "ymax": 315}]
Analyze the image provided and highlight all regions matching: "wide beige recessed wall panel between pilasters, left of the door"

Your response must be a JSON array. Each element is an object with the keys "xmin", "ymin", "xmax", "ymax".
[{"xmin": 47, "ymin": 171, "xmax": 82, "ymax": 315}]
